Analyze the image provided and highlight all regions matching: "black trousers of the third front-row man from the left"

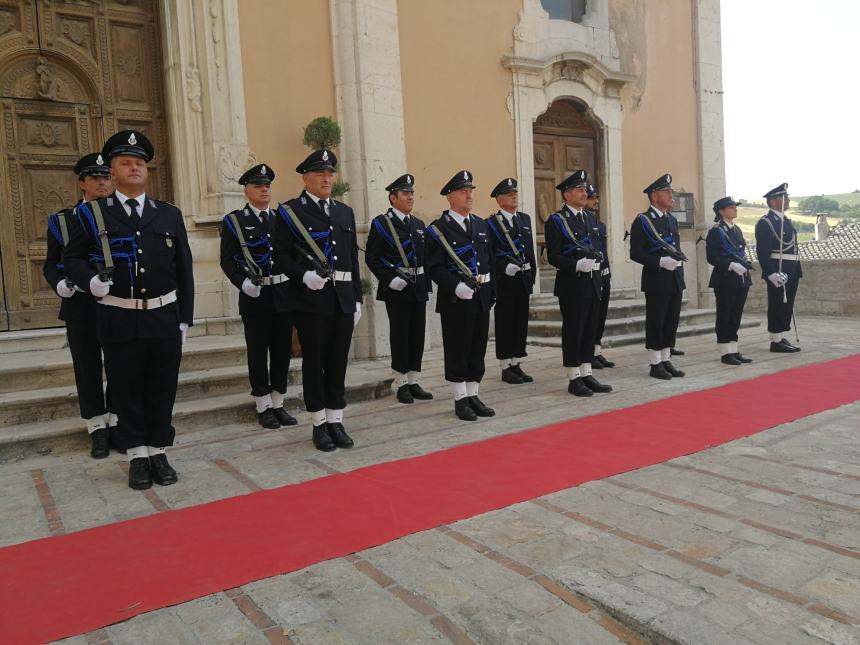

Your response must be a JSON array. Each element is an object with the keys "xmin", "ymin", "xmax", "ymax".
[{"xmin": 439, "ymin": 308, "xmax": 490, "ymax": 383}]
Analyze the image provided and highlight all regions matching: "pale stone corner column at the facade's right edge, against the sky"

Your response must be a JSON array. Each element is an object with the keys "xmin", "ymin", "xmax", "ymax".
[{"xmin": 691, "ymin": 0, "xmax": 726, "ymax": 307}]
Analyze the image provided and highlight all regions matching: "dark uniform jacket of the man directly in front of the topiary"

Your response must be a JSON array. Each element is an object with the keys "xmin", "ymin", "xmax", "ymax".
[{"xmin": 272, "ymin": 191, "xmax": 362, "ymax": 314}]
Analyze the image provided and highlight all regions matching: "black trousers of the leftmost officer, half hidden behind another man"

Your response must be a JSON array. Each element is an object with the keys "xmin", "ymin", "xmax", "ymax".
[{"xmin": 66, "ymin": 320, "xmax": 109, "ymax": 419}]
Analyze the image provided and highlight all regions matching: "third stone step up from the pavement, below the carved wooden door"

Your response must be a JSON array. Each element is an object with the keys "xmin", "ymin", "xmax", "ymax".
[{"xmin": 0, "ymin": 328, "xmax": 252, "ymax": 393}]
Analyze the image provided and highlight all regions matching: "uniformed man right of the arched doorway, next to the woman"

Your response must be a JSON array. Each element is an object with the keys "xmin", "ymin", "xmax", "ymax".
[{"xmin": 630, "ymin": 174, "xmax": 687, "ymax": 380}]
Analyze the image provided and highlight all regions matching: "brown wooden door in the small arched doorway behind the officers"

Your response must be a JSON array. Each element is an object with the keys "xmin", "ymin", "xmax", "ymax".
[{"xmin": 533, "ymin": 99, "xmax": 602, "ymax": 264}]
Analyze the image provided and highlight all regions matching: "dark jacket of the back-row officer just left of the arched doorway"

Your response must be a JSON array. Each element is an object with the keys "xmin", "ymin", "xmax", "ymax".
[{"xmin": 487, "ymin": 211, "xmax": 536, "ymax": 298}]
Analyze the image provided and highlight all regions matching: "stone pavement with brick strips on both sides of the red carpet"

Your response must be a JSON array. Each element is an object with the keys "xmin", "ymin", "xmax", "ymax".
[{"xmin": 0, "ymin": 317, "xmax": 860, "ymax": 645}]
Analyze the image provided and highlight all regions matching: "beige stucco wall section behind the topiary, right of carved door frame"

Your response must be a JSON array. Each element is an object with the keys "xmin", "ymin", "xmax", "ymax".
[{"xmin": 239, "ymin": 0, "xmax": 336, "ymax": 201}]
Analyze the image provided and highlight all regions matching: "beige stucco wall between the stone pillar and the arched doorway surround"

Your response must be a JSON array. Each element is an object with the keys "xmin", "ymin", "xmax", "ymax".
[{"xmin": 392, "ymin": 0, "xmax": 522, "ymax": 219}]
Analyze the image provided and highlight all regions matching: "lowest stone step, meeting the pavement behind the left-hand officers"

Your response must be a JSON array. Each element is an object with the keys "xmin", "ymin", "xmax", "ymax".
[{"xmin": 0, "ymin": 365, "xmax": 392, "ymax": 463}]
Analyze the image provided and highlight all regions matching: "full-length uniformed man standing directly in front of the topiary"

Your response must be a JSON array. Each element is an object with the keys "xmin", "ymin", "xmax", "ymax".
[{"xmin": 272, "ymin": 150, "xmax": 362, "ymax": 452}]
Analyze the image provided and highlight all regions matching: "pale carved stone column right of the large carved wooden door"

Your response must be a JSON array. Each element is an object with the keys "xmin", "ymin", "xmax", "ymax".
[{"xmin": 161, "ymin": 0, "xmax": 252, "ymax": 319}]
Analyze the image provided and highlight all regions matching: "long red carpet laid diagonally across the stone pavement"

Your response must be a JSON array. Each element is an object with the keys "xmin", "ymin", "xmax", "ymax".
[{"xmin": 5, "ymin": 355, "xmax": 860, "ymax": 644}]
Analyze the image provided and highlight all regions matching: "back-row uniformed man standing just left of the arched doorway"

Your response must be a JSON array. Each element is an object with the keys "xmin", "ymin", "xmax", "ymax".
[{"xmin": 487, "ymin": 177, "xmax": 535, "ymax": 385}]
